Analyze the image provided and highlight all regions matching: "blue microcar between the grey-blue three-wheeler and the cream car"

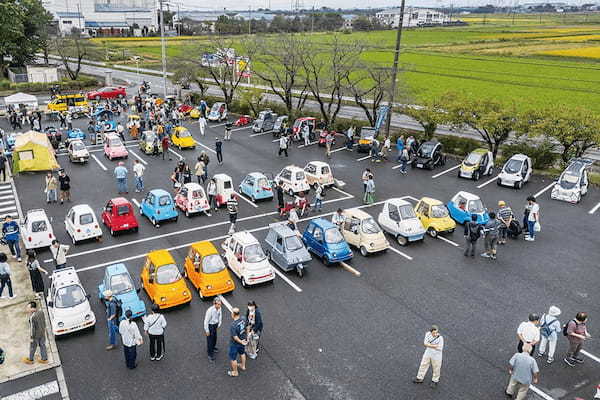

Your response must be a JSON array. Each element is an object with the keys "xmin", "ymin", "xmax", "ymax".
[{"xmin": 302, "ymin": 218, "xmax": 353, "ymax": 265}]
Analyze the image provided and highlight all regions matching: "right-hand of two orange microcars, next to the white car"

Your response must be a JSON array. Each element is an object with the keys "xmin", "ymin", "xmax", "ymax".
[{"xmin": 183, "ymin": 241, "xmax": 235, "ymax": 299}]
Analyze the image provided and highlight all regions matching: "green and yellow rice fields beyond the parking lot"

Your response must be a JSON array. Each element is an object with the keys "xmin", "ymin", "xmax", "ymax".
[{"xmin": 94, "ymin": 14, "xmax": 600, "ymax": 112}]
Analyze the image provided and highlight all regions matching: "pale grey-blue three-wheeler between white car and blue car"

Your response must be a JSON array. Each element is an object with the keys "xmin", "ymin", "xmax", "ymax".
[{"xmin": 265, "ymin": 223, "xmax": 312, "ymax": 277}]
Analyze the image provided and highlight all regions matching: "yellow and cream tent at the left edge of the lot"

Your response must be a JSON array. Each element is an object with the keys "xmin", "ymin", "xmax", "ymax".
[{"xmin": 12, "ymin": 131, "xmax": 60, "ymax": 173}]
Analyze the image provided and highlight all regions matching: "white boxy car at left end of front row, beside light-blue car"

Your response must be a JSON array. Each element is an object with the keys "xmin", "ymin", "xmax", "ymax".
[{"xmin": 46, "ymin": 267, "xmax": 96, "ymax": 336}]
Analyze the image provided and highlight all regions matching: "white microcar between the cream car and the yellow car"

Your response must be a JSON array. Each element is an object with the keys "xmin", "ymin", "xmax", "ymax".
[{"xmin": 377, "ymin": 198, "xmax": 425, "ymax": 246}]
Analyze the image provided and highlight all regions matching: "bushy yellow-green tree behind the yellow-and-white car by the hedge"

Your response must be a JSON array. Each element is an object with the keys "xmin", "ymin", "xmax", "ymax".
[{"xmin": 444, "ymin": 96, "xmax": 522, "ymax": 159}]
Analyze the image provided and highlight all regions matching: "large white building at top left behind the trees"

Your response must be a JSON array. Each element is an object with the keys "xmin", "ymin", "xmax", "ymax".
[{"xmin": 42, "ymin": 0, "xmax": 158, "ymax": 36}]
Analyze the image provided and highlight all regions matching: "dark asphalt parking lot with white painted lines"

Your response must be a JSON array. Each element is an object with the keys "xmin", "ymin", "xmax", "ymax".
[{"xmin": 2, "ymin": 97, "xmax": 600, "ymax": 399}]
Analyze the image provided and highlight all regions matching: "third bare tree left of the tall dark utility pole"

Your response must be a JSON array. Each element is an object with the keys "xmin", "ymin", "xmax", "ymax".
[{"xmin": 250, "ymin": 34, "xmax": 308, "ymax": 118}]
